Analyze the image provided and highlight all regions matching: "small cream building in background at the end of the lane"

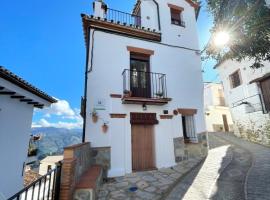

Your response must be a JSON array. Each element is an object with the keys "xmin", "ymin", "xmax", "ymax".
[{"xmin": 204, "ymin": 83, "xmax": 233, "ymax": 132}]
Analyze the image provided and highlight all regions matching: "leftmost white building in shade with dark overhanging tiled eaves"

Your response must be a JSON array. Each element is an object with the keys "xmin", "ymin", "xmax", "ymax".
[{"xmin": 0, "ymin": 66, "xmax": 56, "ymax": 197}]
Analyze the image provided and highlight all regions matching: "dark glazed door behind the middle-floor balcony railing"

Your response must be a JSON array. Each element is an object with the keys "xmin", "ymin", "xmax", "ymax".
[{"xmin": 130, "ymin": 53, "xmax": 151, "ymax": 98}]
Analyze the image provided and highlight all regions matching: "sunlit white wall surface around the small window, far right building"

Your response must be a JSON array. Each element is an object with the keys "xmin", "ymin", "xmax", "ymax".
[{"xmin": 217, "ymin": 60, "xmax": 270, "ymax": 144}]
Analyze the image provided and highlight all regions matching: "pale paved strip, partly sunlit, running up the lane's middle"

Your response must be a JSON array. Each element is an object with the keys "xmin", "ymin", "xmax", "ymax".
[{"xmin": 166, "ymin": 142, "xmax": 232, "ymax": 200}]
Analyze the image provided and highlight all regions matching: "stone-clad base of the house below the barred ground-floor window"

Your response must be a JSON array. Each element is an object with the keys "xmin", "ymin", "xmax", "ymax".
[{"xmin": 174, "ymin": 132, "xmax": 208, "ymax": 163}]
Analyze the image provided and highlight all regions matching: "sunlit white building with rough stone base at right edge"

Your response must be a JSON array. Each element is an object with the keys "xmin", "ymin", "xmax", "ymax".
[{"xmin": 215, "ymin": 60, "xmax": 270, "ymax": 145}]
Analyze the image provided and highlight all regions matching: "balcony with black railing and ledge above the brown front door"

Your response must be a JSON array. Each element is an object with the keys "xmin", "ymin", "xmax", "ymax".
[{"xmin": 122, "ymin": 69, "xmax": 171, "ymax": 105}]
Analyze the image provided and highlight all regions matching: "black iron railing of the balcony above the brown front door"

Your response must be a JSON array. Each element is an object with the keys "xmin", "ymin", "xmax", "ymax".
[{"xmin": 122, "ymin": 69, "xmax": 167, "ymax": 99}]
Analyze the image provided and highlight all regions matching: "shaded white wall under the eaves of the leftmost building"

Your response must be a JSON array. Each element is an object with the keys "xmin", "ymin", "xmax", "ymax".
[{"xmin": 0, "ymin": 95, "xmax": 33, "ymax": 198}]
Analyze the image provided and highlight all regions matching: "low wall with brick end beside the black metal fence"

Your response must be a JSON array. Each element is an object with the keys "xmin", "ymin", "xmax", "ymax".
[{"xmin": 60, "ymin": 142, "xmax": 93, "ymax": 200}]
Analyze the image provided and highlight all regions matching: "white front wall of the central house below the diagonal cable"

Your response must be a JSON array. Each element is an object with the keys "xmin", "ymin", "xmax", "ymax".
[{"xmin": 86, "ymin": 25, "xmax": 205, "ymax": 176}]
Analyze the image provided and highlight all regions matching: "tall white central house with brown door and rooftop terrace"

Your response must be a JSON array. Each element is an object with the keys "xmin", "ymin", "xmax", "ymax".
[{"xmin": 82, "ymin": 0, "xmax": 207, "ymax": 177}]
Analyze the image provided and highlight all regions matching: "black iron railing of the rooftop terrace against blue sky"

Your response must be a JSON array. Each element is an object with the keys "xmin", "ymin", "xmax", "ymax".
[{"xmin": 105, "ymin": 8, "xmax": 141, "ymax": 27}]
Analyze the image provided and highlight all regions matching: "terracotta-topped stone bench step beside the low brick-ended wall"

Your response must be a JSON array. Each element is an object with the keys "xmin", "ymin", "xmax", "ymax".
[{"xmin": 73, "ymin": 165, "xmax": 103, "ymax": 200}]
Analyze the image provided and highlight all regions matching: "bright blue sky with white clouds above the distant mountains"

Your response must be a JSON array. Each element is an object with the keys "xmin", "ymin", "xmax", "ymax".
[{"xmin": 0, "ymin": 0, "xmax": 218, "ymax": 128}]
